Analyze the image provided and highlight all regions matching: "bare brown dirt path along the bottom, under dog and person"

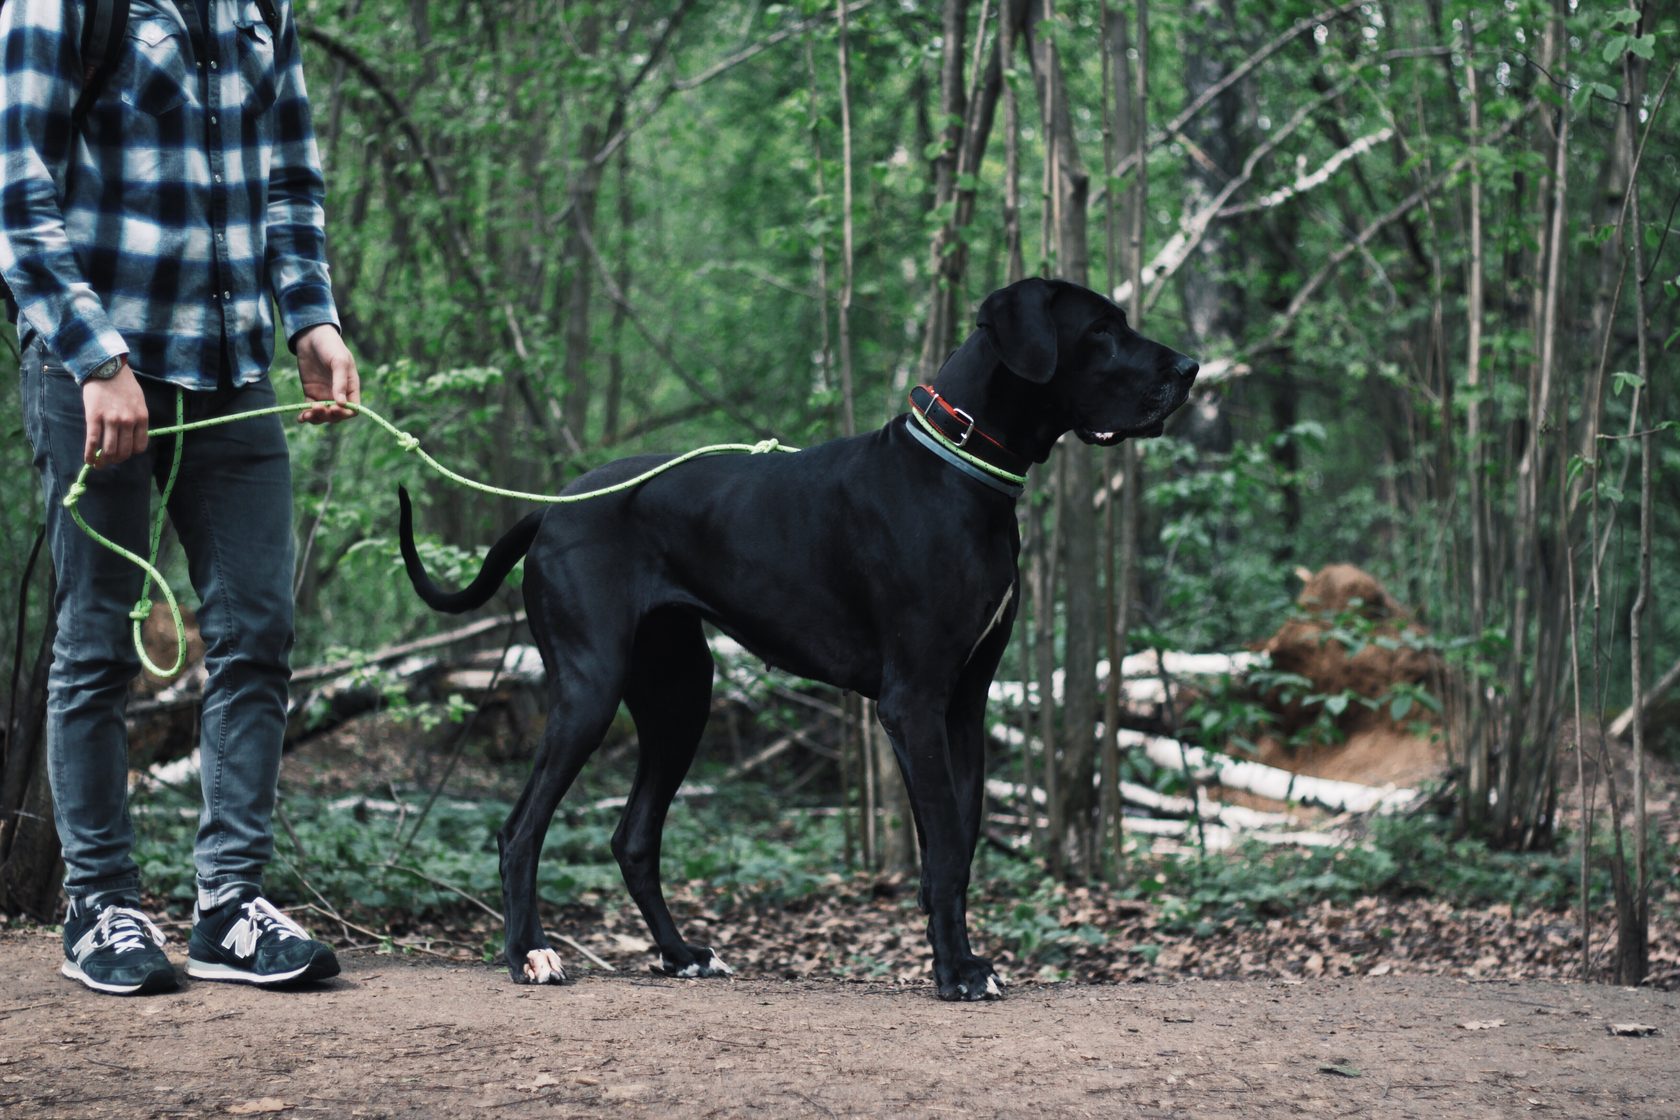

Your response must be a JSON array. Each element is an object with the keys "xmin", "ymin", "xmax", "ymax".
[{"xmin": 0, "ymin": 932, "xmax": 1680, "ymax": 1120}]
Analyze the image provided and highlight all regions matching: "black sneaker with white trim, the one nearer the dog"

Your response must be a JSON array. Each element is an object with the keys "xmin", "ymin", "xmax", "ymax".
[{"xmin": 186, "ymin": 893, "xmax": 338, "ymax": 984}]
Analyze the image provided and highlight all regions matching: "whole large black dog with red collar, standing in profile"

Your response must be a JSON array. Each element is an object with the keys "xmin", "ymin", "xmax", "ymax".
[{"xmin": 400, "ymin": 280, "xmax": 1198, "ymax": 999}]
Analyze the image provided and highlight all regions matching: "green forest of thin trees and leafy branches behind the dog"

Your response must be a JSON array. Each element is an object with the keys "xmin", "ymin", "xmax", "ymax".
[{"xmin": 0, "ymin": 0, "xmax": 1680, "ymax": 979}]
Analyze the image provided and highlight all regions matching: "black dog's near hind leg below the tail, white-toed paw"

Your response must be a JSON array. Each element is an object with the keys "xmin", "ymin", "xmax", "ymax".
[{"xmin": 496, "ymin": 636, "xmax": 625, "ymax": 984}]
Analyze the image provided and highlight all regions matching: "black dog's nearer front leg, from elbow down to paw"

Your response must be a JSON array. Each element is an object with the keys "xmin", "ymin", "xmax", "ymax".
[{"xmin": 880, "ymin": 697, "xmax": 1003, "ymax": 1001}]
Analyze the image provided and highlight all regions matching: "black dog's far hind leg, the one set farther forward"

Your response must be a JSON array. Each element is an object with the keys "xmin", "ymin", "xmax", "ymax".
[{"xmin": 613, "ymin": 608, "xmax": 729, "ymax": 976}]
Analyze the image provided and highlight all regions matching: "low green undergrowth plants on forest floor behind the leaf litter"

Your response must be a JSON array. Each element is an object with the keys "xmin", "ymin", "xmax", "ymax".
[{"xmin": 134, "ymin": 765, "xmax": 1675, "ymax": 974}]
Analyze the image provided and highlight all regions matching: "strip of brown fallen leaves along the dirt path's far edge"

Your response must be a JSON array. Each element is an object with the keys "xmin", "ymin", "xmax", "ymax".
[{"xmin": 240, "ymin": 873, "xmax": 1680, "ymax": 994}]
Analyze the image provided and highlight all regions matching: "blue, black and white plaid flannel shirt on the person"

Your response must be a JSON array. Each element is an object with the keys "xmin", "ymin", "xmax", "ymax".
[{"xmin": 0, "ymin": 0, "xmax": 338, "ymax": 390}]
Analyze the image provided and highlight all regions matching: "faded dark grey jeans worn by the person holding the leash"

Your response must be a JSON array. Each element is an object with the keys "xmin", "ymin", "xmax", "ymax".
[{"xmin": 22, "ymin": 343, "xmax": 294, "ymax": 907}]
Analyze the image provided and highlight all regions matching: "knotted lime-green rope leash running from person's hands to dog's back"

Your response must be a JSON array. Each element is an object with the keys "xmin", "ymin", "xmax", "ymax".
[{"xmin": 64, "ymin": 393, "xmax": 800, "ymax": 677}]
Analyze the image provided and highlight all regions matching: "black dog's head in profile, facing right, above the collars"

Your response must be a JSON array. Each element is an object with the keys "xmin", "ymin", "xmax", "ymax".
[{"xmin": 979, "ymin": 279, "xmax": 1200, "ymax": 447}]
